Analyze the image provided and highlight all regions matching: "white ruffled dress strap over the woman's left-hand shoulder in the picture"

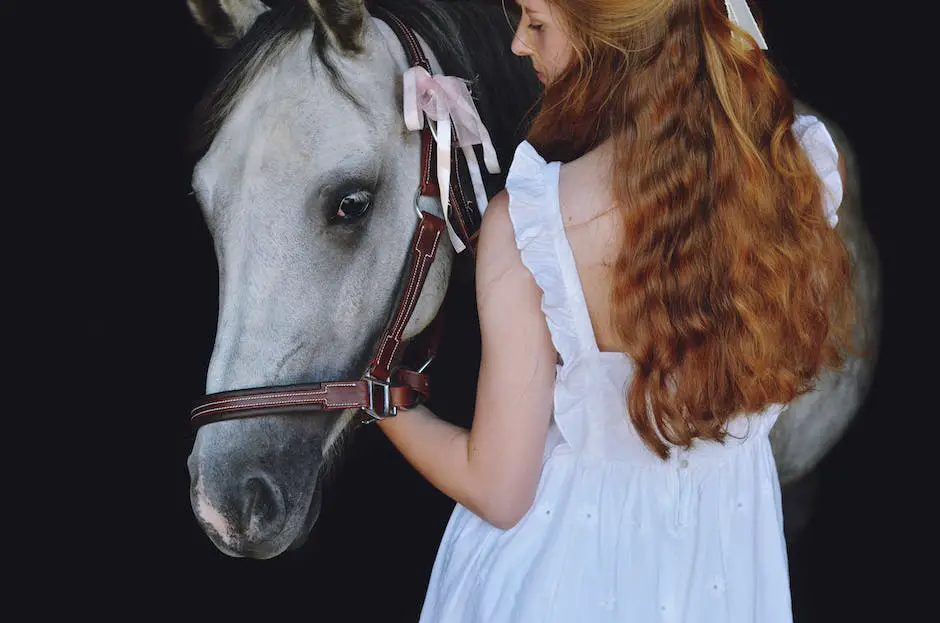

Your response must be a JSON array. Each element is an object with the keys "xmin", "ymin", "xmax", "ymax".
[{"xmin": 506, "ymin": 141, "xmax": 597, "ymax": 365}]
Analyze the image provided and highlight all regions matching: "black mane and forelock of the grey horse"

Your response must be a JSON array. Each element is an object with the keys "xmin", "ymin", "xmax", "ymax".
[{"xmin": 189, "ymin": 0, "xmax": 538, "ymax": 190}]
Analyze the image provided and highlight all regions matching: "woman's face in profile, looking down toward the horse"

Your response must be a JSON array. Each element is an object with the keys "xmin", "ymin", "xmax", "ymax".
[{"xmin": 507, "ymin": 0, "xmax": 572, "ymax": 84}]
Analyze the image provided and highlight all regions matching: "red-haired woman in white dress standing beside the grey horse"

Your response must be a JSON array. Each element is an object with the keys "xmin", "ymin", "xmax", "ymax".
[{"xmin": 380, "ymin": 0, "xmax": 852, "ymax": 623}]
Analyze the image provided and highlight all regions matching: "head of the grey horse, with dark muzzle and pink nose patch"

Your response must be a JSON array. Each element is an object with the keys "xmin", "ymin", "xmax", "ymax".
[{"xmin": 188, "ymin": 0, "xmax": 536, "ymax": 558}]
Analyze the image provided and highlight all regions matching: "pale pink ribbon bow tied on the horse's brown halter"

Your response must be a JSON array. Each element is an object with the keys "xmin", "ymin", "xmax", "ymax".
[{"xmin": 404, "ymin": 66, "xmax": 499, "ymax": 253}]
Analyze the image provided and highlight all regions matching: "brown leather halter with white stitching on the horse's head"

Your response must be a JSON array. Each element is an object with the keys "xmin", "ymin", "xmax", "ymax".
[{"xmin": 191, "ymin": 10, "xmax": 481, "ymax": 428}]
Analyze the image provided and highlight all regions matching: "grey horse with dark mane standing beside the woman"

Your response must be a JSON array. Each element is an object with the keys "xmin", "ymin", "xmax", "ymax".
[{"xmin": 187, "ymin": 0, "xmax": 881, "ymax": 572}]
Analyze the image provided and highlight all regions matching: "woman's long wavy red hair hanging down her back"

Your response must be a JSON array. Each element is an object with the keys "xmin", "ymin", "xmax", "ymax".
[{"xmin": 528, "ymin": 0, "xmax": 854, "ymax": 458}]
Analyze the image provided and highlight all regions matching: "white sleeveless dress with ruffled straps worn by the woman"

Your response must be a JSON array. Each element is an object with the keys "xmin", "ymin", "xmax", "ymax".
[{"xmin": 420, "ymin": 116, "xmax": 842, "ymax": 623}]
